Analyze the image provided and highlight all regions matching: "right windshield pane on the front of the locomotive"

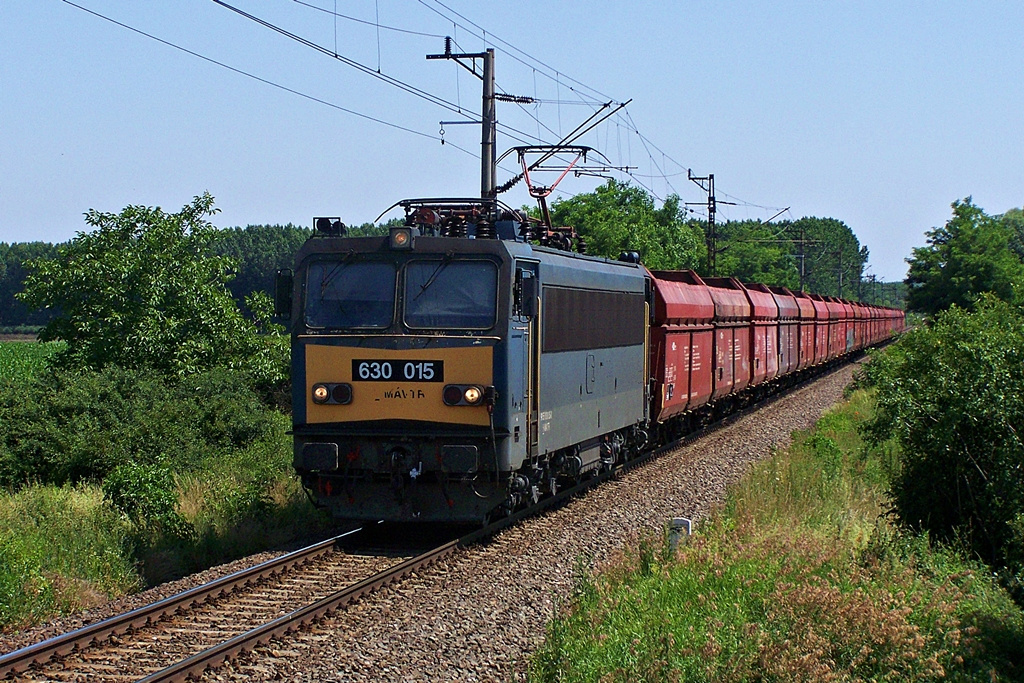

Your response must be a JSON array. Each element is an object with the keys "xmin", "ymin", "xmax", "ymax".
[{"xmin": 404, "ymin": 259, "xmax": 498, "ymax": 330}]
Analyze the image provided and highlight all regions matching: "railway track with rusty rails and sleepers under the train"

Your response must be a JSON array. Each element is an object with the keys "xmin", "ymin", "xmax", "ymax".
[{"xmin": 0, "ymin": 358, "xmax": 856, "ymax": 683}]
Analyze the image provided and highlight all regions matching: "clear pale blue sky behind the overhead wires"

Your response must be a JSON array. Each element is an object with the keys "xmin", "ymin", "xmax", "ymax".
[{"xmin": 0, "ymin": 0, "xmax": 1024, "ymax": 280}]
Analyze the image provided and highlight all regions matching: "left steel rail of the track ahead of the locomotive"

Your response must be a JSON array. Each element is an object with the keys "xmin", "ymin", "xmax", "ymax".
[{"xmin": 0, "ymin": 527, "xmax": 362, "ymax": 680}]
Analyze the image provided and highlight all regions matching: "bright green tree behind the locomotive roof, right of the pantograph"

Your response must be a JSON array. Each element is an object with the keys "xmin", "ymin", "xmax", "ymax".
[{"xmin": 551, "ymin": 180, "xmax": 705, "ymax": 269}]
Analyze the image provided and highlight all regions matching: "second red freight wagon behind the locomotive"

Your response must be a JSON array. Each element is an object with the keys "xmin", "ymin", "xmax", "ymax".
[{"xmin": 705, "ymin": 278, "xmax": 752, "ymax": 398}]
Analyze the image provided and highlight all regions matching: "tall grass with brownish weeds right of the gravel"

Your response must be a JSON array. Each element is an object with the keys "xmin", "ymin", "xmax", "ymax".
[{"xmin": 530, "ymin": 391, "xmax": 1024, "ymax": 681}]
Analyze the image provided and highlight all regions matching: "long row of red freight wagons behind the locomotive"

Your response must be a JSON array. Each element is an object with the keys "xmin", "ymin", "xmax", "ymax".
[{"xmin": 650, "ymin": 270, "xmax": 903, "ymax": 422}]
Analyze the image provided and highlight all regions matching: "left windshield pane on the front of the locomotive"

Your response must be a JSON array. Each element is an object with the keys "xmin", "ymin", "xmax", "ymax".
[{"xmin": 305, "ymin": 261, "xmax": 396, "ymax": 329}]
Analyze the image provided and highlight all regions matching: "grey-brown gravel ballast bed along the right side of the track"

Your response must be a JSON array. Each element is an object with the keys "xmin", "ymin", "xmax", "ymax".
[{"xmin": 211, "ymin": 365, "xmax": 854, "ymax": 681}]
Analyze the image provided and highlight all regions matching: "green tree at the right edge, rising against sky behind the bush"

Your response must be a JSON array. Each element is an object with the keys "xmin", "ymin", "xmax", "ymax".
[{"xmin": 906, "ymin": 197, "xmax": 1024, "ymax": 315}]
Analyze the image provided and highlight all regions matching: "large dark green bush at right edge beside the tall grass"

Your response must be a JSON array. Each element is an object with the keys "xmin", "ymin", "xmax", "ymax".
[{"xmin": 866, "ymin": 297, "xmax": 1024, "ymax": 593}]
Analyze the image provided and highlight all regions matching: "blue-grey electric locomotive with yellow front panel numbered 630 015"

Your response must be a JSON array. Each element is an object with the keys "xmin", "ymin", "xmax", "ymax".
[{"xmin": 279, "ymin": 200, "xmax": 652, "ymax": 523}]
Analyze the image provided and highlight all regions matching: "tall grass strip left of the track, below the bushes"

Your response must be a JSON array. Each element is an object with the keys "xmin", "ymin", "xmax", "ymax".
[{"xmin": 0, "ymin": 471, "xmax": 332, "ymax": 630}]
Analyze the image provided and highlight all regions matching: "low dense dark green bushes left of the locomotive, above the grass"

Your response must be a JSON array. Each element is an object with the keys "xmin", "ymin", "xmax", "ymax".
[{"xmin": 0, "ymin": 367, "xmax": 289, "ymax": 488}]
